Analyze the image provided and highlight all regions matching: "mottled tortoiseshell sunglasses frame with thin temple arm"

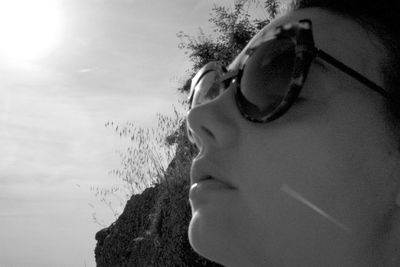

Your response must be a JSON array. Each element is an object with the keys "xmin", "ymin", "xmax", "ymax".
[{"xmin": 189, "ymin": 19, "xmax": 389, "ymax": 123}]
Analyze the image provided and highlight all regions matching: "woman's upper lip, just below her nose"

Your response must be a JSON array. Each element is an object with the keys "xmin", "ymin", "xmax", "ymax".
[{"xmin": 190, "ymin": 158, "xmax": 236, "ymax": 189}]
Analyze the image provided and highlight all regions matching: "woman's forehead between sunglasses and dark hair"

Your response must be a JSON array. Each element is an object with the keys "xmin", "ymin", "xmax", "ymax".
[{"xmin": 231, "ymin": 8, "xmax": 385, "ymax": 81}]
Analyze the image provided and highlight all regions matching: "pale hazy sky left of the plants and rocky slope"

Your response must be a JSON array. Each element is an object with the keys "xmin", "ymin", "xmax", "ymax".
[{"xmin": 0, "ymin": 0, "xmax": 268, "ymax": 267}]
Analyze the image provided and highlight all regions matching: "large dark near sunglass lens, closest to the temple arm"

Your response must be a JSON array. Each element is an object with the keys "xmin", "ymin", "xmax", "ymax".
[{"xmin": 240, "ymin": 39, "xmax": 295, "ymax": 117}]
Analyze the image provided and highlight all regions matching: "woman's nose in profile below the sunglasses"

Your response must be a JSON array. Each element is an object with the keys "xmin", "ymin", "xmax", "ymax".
[{"xmin": 186, "ymin": 90, "xmax": 239, "ymax": 153}]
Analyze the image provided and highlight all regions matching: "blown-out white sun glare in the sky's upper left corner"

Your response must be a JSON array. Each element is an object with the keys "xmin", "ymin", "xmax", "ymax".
[{"xmin": 0, "ymin": 0, "xmax": 61, "ymax": 61}]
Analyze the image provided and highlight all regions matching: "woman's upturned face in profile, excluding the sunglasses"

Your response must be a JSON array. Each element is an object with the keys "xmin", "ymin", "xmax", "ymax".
[{"xmin": 187, "ymin": 9, "xmax": 398, "ymax": 266}]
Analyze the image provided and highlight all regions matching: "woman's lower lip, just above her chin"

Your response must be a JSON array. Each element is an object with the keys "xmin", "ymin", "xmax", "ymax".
[{"xmin": 189, "ymin": 179, "xmax": 234, "ymax": 199}]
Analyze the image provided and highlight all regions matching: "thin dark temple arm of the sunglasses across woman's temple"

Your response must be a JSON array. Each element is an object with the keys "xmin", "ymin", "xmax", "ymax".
[{"xmin": 316, "ymin": 48, "xmax": 389, "ymax": 98}]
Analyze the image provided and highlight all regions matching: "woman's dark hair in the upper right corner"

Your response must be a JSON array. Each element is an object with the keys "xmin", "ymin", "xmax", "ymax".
[{"xmin": 289, "ymin": 0, "xmax": 400, "ymax": 131}]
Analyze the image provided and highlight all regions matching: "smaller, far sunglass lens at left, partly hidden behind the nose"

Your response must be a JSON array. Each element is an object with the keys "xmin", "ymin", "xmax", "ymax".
[{"xmin": 192, "ymin": 71, "xmax": 224, "ymax": 107}]
